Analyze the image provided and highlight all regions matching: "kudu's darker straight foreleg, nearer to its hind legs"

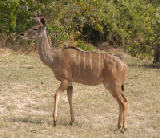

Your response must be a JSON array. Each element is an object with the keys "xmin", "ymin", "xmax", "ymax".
[{"xmin": 67, "ymin": 86, "xmax": 74, "ymax": 125}]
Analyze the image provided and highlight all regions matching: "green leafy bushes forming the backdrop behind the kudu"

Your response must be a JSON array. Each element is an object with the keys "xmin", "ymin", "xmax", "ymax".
[{"xmin": 0, "ymin": 0, "xmax": 160, "ymax": 57}]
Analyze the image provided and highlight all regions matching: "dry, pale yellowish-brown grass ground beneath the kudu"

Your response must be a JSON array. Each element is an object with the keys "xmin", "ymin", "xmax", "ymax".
[{"xmin": 0, "ymin": 50, "xmax": 160, "ymax": 138}]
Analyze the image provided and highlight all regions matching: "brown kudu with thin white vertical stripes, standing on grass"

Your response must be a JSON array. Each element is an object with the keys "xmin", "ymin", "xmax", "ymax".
[{"xmin": 20, "ymin": 17, "xmax": 128, "ymax": 132}]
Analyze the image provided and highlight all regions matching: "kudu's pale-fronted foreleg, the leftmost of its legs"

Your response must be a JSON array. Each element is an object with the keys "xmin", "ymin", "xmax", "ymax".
[{"xmin": 53, "ymin": 80, "xmax": 68, "ymax": 126}]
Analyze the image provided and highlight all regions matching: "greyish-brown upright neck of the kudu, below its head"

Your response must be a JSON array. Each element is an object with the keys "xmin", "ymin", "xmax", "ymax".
[{"xmin": 37, "ymin": 29, "xmax": 55, "ymax": 67}]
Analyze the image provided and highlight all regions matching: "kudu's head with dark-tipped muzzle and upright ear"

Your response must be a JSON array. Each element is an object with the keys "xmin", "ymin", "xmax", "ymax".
[{"xmin": 20, "ymin": 17, "xmax": 46, "ymax": 39}]
